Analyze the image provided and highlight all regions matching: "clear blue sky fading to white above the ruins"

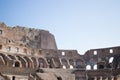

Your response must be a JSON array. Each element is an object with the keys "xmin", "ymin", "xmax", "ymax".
[{"xmin": 0, "ymin": 0, "xmax": 120, "ymax": 53}]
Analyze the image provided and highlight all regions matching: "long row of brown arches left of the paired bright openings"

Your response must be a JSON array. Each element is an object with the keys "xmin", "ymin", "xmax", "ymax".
[{"xmin": 0, "ymin": 53, "xmax": 84, "ymax": 69}]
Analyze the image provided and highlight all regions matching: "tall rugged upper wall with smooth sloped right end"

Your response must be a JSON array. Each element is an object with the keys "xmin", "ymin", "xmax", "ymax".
[{"xmin": 0, "ymin": 23, "xmax": 57, "ymax": 49}]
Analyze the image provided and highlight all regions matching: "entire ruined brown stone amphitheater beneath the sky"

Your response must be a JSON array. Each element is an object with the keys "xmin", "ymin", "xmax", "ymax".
[{"xmin": 0, "ymin": 23, "xmax": 120, "ymax": 80}]
